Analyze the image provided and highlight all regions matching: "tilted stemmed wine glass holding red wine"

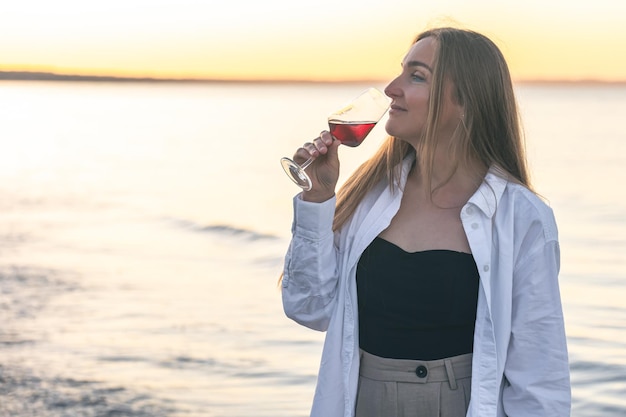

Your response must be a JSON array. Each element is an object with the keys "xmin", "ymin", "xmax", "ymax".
[{"xmin": 280, "ymin": 88, "xmax": 389, "ymax": 191}]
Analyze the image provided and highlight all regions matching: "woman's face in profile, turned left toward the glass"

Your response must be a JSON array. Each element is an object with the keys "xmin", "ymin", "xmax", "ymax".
[{"xmin": 385, "ymin": 37, "xmax": 462, "ymax": 147}]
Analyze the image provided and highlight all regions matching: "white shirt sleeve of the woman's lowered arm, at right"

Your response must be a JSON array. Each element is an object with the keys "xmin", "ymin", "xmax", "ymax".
[{"xmin": 502, "ymin": 239, "xmax": 571, "ymax": 417}]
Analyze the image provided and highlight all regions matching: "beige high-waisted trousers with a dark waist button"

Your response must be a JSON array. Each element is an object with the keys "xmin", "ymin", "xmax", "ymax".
[{"xmin": 356, "ymin": 351, "xmax": 472, "ymax": 417}]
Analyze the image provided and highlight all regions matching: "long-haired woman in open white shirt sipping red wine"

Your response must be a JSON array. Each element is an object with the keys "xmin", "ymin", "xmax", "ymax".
[{"xmin": 282, "ymin": 28, "xmax": 571, "ymax": 417}]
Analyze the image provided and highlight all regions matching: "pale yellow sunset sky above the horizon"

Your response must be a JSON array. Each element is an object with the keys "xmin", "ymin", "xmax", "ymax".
[{"xmin": 0, "ymin": 0, "xmax": 626, "ymax": 81}]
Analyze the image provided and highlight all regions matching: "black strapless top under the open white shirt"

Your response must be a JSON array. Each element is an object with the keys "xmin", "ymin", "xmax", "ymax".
[{"xmin": 356, "ymin": 238, "xmax": 479, "ymax": 360}]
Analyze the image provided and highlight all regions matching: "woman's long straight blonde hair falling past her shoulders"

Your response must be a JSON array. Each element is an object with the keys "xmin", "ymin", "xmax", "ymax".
[{"xmin": 333, "ymin": 27, "xmax": 531, "ymax": 230}]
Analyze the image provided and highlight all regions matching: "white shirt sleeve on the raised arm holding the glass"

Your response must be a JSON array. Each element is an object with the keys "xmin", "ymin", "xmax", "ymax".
[{"xmin": 282, "ymin": 195, "xmax": 339, "ymax": 331}]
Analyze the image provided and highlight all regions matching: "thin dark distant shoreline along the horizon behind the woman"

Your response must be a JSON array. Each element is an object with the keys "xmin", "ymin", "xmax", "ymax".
[{"xmin": 0, "ymin": 71, "xmax": 626, "ymax": 85}]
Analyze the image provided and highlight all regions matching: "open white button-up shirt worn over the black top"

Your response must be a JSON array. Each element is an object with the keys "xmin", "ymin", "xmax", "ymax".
[{"xmin": 282, "ymin": 160, "xmax": 571, "ymax": 417}]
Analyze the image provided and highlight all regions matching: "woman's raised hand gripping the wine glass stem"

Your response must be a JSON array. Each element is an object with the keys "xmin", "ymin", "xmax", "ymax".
[{"xmin": 293, "ymin": 130, "xmax": 340, "ymax": 203}]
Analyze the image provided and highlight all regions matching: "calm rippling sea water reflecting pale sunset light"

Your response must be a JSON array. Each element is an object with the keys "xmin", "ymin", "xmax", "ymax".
[{"xmin": 0, "ymin": 82, "xmax": 626, "ymax": 417}]
